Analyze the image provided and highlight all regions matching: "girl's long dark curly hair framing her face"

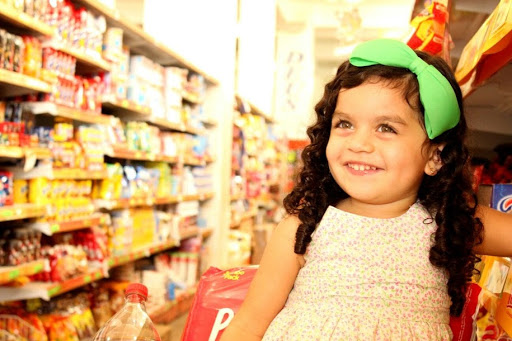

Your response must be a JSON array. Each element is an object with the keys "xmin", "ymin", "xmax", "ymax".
[{"xmin": 284, "ymin": 51, "xmax": 483, "ymax": 316}]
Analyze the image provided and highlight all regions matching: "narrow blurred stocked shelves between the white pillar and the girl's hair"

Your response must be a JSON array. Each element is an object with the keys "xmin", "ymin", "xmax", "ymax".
[{"xmin": 228, "ymin": 96, "xmax": 283, "ymax": 267}]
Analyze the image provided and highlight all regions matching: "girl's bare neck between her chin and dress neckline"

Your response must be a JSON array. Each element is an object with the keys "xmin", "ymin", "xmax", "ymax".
[{"xmin": 336, "ymin": 197, "xmax": 416, "ymax": 219}]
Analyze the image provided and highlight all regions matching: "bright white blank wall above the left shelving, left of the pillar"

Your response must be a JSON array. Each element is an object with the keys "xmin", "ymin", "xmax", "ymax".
[{"xmin": 143, "ymin": 0, "xmax": 237, "ymax": 84}]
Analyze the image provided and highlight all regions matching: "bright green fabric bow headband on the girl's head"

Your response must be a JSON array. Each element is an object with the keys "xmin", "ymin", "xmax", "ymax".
[{"xmin": 349, "ymin": 39, "xmax": 460, "ymax": 139}]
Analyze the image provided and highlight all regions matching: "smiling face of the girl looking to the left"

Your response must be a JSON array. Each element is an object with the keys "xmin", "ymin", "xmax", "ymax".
[{"xmin": 326, "ymin": 81, "xmax": 438, "ymax": 207}]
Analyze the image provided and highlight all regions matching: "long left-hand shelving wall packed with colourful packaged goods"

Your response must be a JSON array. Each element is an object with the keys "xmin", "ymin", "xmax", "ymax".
[{"xmin": 0, "ymin": 0, "xmax": 219, "ymax": 340}]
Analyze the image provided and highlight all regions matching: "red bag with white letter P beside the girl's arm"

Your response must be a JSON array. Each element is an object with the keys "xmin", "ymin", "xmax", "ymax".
[{"xmin": 181, "ymin": 266, "xmax": 258, "ymax": 341}]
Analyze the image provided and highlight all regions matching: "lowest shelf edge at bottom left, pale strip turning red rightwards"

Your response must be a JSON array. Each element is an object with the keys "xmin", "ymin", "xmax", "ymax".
[{"xmin": 0, "ymin": 269, "xmax": 105, "ymax": 302}]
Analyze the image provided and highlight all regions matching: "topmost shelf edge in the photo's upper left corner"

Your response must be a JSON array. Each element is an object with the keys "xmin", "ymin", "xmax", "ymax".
[{"xmin": 0, "ymin": 3, "xmax": 55, "ymax": 36}]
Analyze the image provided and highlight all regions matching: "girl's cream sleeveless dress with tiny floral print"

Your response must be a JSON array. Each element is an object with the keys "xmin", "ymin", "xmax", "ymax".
[{"xmin": 263, "ymin": 203, "xmax": 452, "ymax": 341}]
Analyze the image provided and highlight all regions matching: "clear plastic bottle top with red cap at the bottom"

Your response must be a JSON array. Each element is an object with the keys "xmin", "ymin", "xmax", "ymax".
[{"xmin": 94, "ymin": 283, "xmax": 161, "ymax": 341}]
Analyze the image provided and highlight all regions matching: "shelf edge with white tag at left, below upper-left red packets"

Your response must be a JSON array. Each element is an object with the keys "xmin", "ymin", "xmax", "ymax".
[{"xmin": 22, "ymin": 102, "xmax": 112, "ymax": 125}]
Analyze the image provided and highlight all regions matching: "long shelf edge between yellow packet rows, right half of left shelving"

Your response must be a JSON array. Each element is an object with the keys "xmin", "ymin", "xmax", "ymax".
[{"xmin": 95, "ymin": 193, "xmax": 214, "ymax": 210}]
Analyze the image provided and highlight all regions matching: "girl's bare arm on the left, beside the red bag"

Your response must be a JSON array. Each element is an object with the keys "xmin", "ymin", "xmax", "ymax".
[{"xmin": 221, "ymin": 216, "xmax": 304, "ymax": 341}]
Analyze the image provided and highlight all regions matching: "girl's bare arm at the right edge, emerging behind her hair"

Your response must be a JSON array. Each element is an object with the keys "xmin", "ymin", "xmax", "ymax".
[{"xmin": 476, "ymin": 205, "xmax": 512, "ymax": 257}]
